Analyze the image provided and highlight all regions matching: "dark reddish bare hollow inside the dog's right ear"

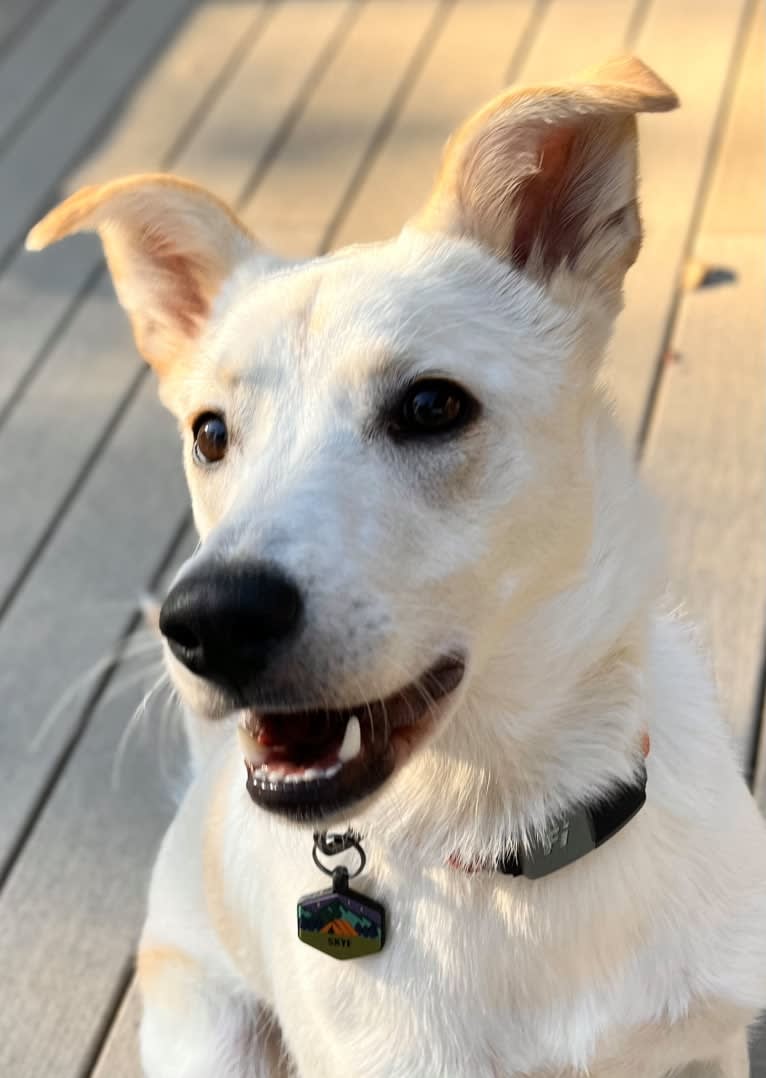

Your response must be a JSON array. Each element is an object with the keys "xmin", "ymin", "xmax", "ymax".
[{"xmin": 511, "ymin": 126, "xmax": 580, "ymax": 271}]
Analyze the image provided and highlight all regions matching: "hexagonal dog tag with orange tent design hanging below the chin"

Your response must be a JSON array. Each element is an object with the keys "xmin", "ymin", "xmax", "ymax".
[{"xmin": 297, "ymin": 867, "xmax": 386, "ymax": 960}]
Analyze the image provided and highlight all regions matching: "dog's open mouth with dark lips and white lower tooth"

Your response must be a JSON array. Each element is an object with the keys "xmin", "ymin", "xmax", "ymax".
[{"xmin": 239, "ymin": 655, "xmax": 465, "ymax": 819}]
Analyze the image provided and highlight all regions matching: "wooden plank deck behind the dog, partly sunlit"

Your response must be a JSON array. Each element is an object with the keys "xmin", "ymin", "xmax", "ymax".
[{"xmin": 0, "ymin": 0, "xmax": 766, "ymax": 1078}]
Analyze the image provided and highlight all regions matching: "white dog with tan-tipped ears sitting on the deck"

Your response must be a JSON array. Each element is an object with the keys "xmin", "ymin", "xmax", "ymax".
[{"xmin": 28, "ymin": 57, "xmax": 766, "ymax": 1078}]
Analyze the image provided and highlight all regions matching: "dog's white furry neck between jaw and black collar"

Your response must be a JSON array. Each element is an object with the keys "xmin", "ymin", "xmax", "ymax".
[{"xmin": 355, "ymin": 405, "xmax": 658, "ymax": 862}]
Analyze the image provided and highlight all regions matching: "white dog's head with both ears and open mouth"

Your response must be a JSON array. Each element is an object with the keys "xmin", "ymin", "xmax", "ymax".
[{"xmin": 29, "ymin": 59, "xmax": 677, "ymax": 817}]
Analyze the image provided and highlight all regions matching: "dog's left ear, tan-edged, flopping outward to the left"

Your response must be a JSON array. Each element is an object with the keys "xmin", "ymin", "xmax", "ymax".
[{"xmin": 27, "ymin": 174, "xmax": 257, "ymax": 375}]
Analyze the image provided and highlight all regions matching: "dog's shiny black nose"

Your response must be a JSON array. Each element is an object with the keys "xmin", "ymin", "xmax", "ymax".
[{"xmin": 159, "ymin": 564, "xmax": 303, "ymax": 693}]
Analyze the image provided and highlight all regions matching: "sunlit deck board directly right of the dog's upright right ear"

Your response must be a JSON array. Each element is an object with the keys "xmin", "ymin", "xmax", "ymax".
[{"xmin": 607, "ymin": 0, "xmax": 747, "ymax": 440}]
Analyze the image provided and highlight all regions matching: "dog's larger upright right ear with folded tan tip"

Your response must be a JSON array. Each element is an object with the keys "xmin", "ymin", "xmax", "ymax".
[{"xmin": 413, "ymin": 57, "xmax": 679, "ymax": 291}]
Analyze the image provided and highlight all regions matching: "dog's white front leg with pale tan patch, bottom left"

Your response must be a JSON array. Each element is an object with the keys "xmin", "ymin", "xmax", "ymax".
[{"xmin": 138, "ymin": 946, "xmax": 290, "ymax": 1078}]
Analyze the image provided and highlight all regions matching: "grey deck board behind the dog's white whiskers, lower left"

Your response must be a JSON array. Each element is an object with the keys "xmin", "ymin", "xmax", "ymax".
[{"xmin": 0, "ymin": 532, "xmax": 193, "ymax": 1078}]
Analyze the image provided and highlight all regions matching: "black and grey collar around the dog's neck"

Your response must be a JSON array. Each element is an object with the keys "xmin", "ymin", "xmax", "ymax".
[{"xmin": 449, "ymin": 734, "xmax": 650, "ymax": 880}]
